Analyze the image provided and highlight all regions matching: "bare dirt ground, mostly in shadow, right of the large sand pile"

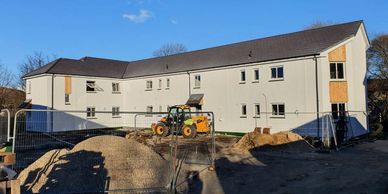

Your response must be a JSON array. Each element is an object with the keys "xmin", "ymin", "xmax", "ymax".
[{"xmin": 147, "ymin": 136, "xmax": 388, "ymax": 194}]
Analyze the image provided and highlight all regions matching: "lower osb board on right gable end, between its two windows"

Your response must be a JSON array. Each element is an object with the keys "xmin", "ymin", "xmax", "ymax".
[{"xmin": 329, "ymin": 81, "xmax": 348, "ymax": 103}]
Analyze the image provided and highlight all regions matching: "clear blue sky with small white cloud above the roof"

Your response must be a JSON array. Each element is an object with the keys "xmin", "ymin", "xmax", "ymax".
[{"xmin": 0, "ymin": 0, "xmax": 388, "ymax": 72}]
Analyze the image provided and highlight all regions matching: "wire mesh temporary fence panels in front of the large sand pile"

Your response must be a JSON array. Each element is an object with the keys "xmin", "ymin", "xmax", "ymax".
[{"xmin": 13, "ymin": 109, "xmax": 215, "ymax": 193}]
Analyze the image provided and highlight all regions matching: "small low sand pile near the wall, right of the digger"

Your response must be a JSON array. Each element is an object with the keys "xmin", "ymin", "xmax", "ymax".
[{"xmin": 233, "ymin": 131, "xmax": 303, "ymax": 150}]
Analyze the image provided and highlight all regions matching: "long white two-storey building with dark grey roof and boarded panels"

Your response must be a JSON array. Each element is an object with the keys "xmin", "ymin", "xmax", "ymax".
[{"xmin": 25, "ymin": 21, "xmax": 369, "ymax": 135}]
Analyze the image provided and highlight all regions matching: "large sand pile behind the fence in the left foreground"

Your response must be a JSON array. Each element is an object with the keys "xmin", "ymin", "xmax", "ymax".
[{"xmin": 18, "ymin": 136, "xmax": 169, "ymax": 193}]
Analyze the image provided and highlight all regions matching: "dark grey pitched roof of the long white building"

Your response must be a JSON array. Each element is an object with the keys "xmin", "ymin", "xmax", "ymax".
[{"xmin": 25, "ymin": 21, "xmax": 362, "ymax": 78}]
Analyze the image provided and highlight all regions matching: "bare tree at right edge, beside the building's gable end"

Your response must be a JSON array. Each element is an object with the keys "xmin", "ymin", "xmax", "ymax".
[{"xmin": 367, "ymin": 33, "xmax": 388, "ymax": 130}]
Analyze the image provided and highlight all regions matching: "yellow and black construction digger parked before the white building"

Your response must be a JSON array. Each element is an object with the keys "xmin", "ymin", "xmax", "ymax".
[{"xmin": 151, "ymin": 105, "xmax": 210, "ymax": 138}]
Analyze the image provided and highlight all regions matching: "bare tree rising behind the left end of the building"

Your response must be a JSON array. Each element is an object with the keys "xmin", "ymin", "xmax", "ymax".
[{"xmin": 17, "ymin": 52, "xmax": 50, "ymax": 90}]
